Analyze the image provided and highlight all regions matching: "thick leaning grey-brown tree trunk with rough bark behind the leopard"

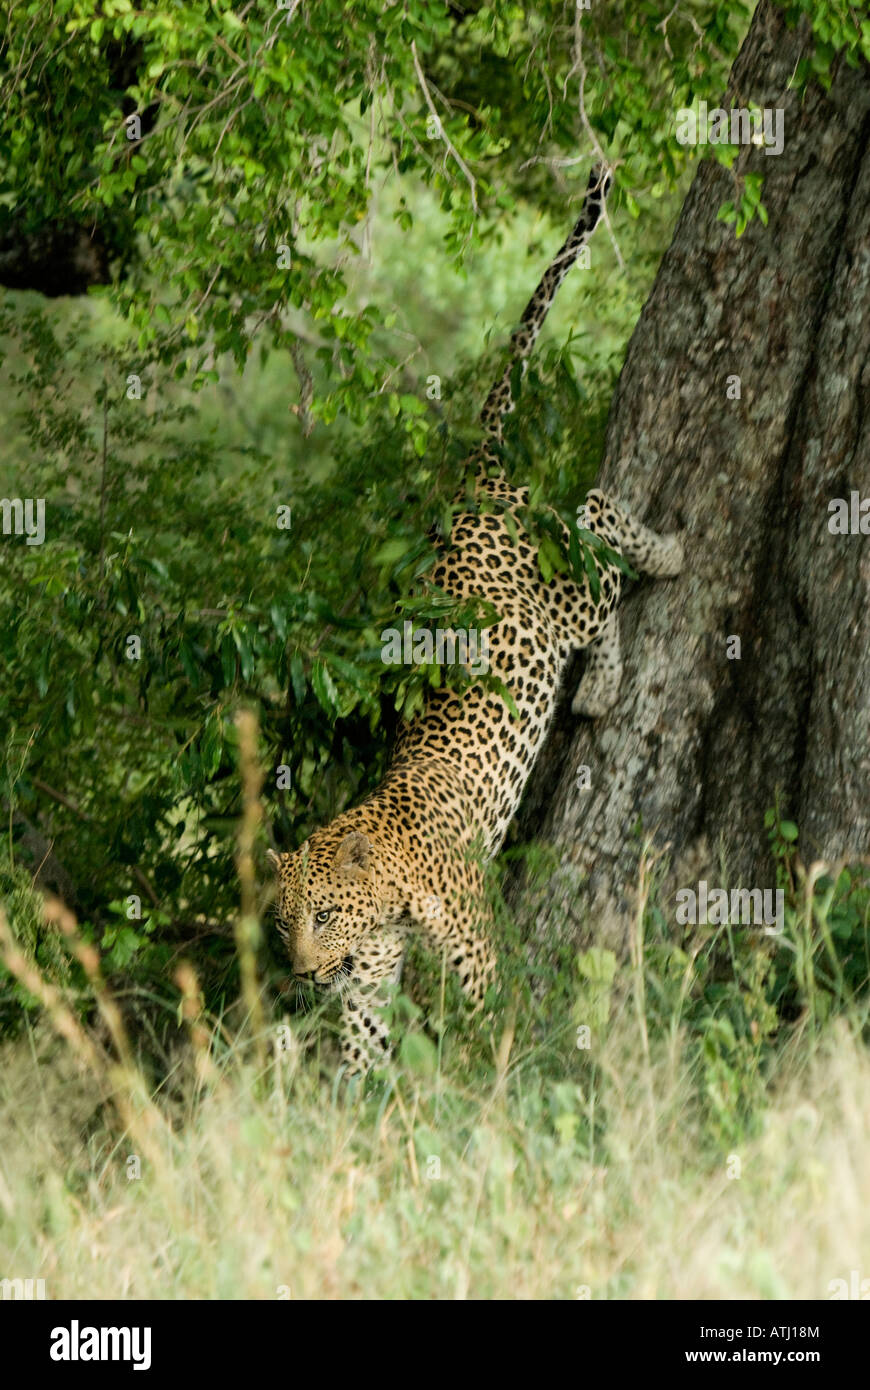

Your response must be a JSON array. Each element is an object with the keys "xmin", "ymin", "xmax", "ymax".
[{"xmin": 520, "ymin": 0, "xmax": 870, "ymax": 948}]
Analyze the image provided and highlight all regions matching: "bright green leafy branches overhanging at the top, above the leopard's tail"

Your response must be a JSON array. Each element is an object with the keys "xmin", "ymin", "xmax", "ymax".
[{"xmin": 0, "ymin": 0, "xmax": 749, "ymax": 417}]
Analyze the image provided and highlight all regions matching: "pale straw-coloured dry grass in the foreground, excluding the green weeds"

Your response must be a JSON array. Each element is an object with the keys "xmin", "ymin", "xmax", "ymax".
[{"xmin": 0, "ymin": 973, "xmax": 870, "ymax": 1298}]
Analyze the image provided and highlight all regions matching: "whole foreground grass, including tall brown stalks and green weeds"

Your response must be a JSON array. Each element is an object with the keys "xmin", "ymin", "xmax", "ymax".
[{"xmin": 0, "ymin": 745, "xmax": 870, "ymax": 1298}]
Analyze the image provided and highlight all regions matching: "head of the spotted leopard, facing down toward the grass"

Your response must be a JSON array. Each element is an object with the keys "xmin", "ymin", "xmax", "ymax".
[{"xmin": 270, "ymin": 826, "xmax": 381, "ymax": 986}]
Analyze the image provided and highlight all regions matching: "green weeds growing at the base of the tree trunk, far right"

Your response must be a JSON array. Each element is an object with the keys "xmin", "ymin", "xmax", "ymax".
[{"xmin": 636, "ymin": 813, "xmax": 870, "ymax": 1145}]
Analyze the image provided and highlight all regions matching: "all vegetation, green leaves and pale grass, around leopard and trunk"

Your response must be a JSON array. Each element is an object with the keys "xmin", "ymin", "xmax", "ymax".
[{"xmin": 0, "ymin": 0, "xmax": 870, "ymax": 1298}]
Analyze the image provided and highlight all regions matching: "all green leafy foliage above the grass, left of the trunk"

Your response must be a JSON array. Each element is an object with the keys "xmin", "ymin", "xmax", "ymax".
[{"xmin": 0, "ymin": 0, "xmax": 864, "ymax": 1028}]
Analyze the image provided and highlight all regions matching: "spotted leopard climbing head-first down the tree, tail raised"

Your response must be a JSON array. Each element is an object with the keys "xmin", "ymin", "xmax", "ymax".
[{"xmin": 270, "ymin": 165, "xmax": 684, "ymax": 1076}]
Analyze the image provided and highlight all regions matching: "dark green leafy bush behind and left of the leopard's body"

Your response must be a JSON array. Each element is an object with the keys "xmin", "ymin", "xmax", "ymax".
[{"xmin": 0, "ymin": 279, "xmax": 617, "ymax": 1011}]
